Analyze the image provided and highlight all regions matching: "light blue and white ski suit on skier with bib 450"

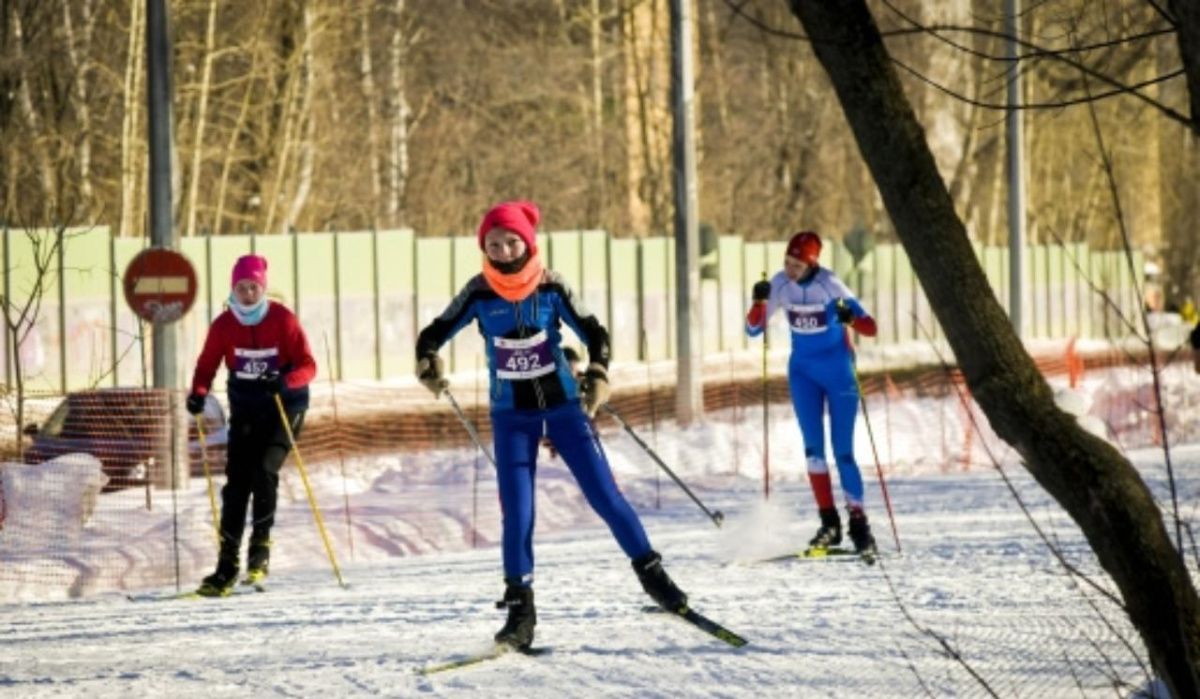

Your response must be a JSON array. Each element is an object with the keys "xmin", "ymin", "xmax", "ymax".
[{"xmin": 746, "ymin": 267, "xmax": 869, "ymax": 508}]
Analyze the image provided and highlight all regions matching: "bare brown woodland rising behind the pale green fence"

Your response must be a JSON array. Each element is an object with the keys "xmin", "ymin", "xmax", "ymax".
[{"xmin": 0, "ymin": 0, "xmax": 1200, "ymax": 305}]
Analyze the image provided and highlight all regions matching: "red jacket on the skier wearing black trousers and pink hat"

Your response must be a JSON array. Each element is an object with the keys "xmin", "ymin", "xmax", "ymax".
[{"xmin": 192, "ymin": 301, "xmax": 317, "ymax": 410}]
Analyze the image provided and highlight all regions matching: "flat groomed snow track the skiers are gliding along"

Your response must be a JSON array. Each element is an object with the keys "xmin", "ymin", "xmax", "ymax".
[{"xmin": 0, "ymin": 447, "xmax": 1200, "ymax": 698}]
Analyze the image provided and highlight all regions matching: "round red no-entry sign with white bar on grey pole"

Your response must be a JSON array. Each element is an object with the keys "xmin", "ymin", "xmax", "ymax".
[{"xmin": 122, "ymin": 247, "xmax": 196, "ymax": 323}]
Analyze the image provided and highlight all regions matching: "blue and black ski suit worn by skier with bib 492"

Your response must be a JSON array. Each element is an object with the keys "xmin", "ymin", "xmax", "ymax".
[{"xmin": 416, "ymin": 270, "xmax": 650, "ymax": 585}]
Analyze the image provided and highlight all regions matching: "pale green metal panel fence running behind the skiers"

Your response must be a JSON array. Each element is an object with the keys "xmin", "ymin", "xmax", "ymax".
[{"xmin": 0, "ymin": 227, "xmax": 1141, "ymax": 392}]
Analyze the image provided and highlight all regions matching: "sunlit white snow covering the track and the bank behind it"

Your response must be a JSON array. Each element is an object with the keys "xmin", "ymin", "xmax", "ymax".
[{"xmin": 0, "ymin": 357, "xmax": 1200, "ymax": 698}]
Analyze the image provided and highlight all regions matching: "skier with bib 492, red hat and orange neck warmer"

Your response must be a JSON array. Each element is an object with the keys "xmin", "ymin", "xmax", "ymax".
[{"xmin": 416, "ymin": 201, "xmax": 688, "ymax": 650}]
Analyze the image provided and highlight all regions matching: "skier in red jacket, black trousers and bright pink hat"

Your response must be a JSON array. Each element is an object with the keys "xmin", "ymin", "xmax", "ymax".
[{"xmin": 187, "ymin": 255, "xmax": 317, "ymax": 597}]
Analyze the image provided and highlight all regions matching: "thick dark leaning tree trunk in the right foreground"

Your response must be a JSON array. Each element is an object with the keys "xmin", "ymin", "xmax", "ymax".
[{"xmin": 791, "ymin": 0, "xmax": 1200, "ymax": 697}]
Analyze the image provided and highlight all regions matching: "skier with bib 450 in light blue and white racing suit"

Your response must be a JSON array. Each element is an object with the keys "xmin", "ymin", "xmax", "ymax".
[{"xmin": 746, "ymin": 231, "xmax": 876, "ymax": 555}]
